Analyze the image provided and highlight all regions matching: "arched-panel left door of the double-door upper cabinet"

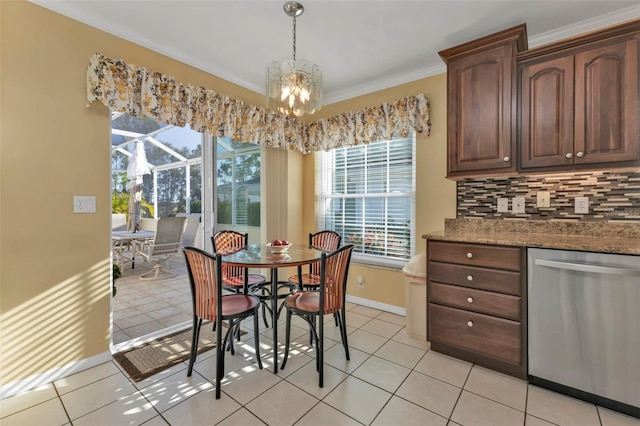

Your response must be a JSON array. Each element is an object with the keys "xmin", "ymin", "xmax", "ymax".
[{"xmin": 520, "ymin": 56, "xmax": 574, "ymax": 169}]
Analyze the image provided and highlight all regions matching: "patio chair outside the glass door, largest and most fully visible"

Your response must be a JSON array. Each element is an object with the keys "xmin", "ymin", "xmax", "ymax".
[{"xmin": 133, "ymin": 217, "xmax": 185, "ymax": 280}]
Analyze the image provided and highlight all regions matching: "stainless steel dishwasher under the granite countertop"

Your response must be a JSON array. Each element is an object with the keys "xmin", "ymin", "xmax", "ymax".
[{"xmin": 527, "ymin": 248, "xmax": 640, "ymax": 417}]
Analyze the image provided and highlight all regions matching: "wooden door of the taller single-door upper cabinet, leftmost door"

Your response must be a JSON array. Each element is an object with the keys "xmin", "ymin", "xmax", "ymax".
[{"xmin": 447, "ymin": 43, "xmax": 515, "ymax": 176}]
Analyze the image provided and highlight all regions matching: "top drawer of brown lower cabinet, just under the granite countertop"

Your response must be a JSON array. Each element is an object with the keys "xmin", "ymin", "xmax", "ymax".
[{"xmin": 428, "ymin": 240, "xmax": 522, "ymax": 271}]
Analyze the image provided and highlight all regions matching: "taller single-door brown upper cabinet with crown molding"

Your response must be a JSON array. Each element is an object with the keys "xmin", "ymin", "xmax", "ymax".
[{"xmin": 439, "ymin": 24, "xmax": 527, "ymax": 179}]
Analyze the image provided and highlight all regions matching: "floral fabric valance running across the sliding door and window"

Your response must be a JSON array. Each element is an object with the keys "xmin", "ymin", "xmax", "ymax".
[{"xmin": 87, "ymin": 53, "xmax": 431, "ymax": 153}]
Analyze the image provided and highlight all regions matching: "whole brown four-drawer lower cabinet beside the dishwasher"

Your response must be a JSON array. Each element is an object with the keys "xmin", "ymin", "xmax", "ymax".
[{"xmin": 427, "ymin": 240, "xmax": 527, "ymax": 379}]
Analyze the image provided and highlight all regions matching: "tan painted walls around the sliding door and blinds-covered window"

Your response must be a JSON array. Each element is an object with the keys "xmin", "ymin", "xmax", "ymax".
[{"xmin": 0, "ymin": 1, "xmax": 455, "ymax": 385}]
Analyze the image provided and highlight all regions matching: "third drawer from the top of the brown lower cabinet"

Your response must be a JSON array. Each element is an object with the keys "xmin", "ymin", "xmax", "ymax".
[{"xmin": 427, "ymin": 283, "xmax": 521, "ymax": 321}]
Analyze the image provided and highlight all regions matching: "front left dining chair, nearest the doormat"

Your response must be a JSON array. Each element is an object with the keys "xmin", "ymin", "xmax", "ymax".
[{"xmin": 183, "ymin": 247, "xmax": 262, "ymax": 399}]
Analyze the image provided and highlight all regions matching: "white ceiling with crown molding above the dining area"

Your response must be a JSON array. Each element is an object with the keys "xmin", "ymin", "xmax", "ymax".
[{"xmin": 31, "ymin": 0, "xmax": 640, "ymax": 105}]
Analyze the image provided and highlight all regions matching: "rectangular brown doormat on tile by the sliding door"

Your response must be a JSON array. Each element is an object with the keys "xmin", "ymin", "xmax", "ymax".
[{"xmin": 113, "ymin": 322, "xmax": 246, "ymax": 382}]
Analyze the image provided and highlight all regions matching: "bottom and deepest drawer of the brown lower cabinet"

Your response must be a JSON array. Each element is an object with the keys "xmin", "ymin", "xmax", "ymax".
[{"xmin": 427, "ymin": 303, "xmax": 522, "ymax": 364}]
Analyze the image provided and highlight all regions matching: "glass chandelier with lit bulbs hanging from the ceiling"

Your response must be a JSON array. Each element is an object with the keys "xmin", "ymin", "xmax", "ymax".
[{"xmin": 266, "ymin": 1, "xmax": 322, "ymax": 117}]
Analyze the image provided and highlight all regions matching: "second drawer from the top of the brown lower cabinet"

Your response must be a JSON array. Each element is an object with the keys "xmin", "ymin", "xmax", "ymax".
[{"xmin": 427, "ymin": 262, "xmax": 522, "ymax": 296}]
